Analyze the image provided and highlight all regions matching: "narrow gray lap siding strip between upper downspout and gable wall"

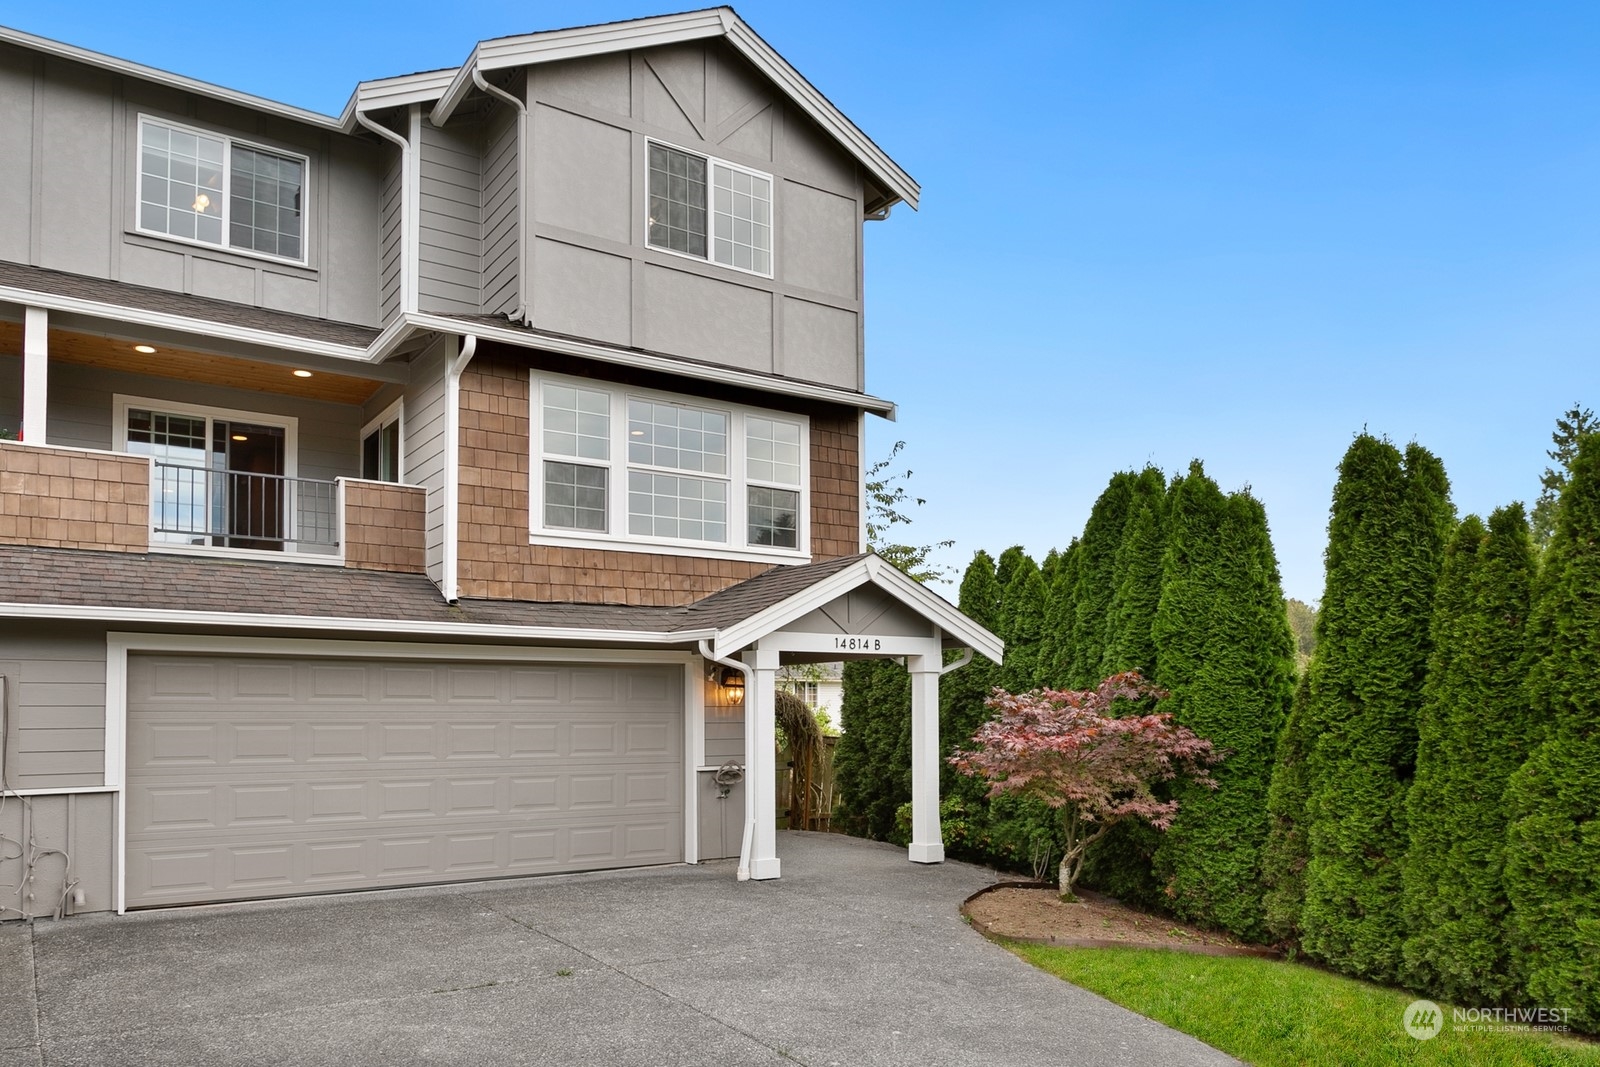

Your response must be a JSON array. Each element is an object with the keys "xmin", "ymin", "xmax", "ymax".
[{"xmin": 418, "ymin": 122, "xmax": 483, "ymax": 315}]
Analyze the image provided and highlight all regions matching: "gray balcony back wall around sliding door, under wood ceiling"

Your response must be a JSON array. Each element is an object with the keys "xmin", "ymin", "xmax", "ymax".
[{"xmin": 46, "ymin": 362, "xmax": 362, "ymax": 480}]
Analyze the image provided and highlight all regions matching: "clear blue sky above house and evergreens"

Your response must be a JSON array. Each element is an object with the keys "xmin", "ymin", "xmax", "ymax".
[{"xmin": 15, "ymin": 0, "xmax": 1600, "ymax": 600}]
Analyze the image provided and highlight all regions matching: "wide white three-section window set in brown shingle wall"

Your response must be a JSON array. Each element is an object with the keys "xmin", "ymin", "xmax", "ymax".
[{"xmin": 530, "ymin": 373, "xmax": 810, "ymax": 558}]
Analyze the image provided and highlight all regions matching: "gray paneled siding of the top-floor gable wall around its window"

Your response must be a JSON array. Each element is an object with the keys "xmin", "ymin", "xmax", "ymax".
[{"xmin": 508, "ymin": 42, "xmax": 864, "ymax": 389}]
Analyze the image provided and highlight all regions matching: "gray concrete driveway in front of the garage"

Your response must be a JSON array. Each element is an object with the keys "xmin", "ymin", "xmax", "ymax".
[{"xmin": 0, "ymin": 833, "xmax": 1234, "ymax": 1067}]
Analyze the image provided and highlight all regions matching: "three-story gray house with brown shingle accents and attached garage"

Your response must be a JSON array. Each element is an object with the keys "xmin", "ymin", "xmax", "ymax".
[{"xmin": 0, "ymin": 8, "xmax": 1002, "ymax": 917}]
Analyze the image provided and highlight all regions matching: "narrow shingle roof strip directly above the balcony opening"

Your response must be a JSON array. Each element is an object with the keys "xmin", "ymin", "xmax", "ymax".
[{"xmin": 0, "ymin": 259, "xmax": 378, "ymax": 349}]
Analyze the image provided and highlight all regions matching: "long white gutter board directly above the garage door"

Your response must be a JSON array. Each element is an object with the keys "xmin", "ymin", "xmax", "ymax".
[{"xmin": 0, "ymin": 603, "xmax": 715, "ymax": 645}]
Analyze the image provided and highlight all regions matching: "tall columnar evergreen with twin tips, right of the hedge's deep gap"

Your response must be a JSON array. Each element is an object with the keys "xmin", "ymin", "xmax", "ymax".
[{"xmin": 1301, "ymin": 434, "xmax": 1453, "ymax": 982}]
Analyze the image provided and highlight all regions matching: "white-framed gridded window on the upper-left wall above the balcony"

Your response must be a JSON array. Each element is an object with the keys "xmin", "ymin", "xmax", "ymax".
[{"xmin": 138, "ymin": 115, "xmax": 310, "ymax": 262}]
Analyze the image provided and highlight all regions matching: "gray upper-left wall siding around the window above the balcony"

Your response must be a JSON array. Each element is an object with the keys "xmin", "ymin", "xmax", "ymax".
[{"xmin": 0, "ymin": 46, "xmax": 382, "ymax": 325}]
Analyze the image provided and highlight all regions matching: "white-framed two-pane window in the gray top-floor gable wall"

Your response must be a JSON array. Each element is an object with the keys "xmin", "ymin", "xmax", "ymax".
[{"xmin": 645, "ymin": 141, "xmax": 773, "ymax": 278}]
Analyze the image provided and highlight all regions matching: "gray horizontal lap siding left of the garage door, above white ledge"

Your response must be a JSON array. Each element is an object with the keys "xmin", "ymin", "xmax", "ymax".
[{"xmin": 0, "ymin": 622, "xmax": 106, "ymax": 789}]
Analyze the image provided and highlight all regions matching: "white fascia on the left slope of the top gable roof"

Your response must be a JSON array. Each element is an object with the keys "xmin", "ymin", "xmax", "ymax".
[{"xmin": 429, "ymin": 8, "xmax": 733, "ymax": 126}]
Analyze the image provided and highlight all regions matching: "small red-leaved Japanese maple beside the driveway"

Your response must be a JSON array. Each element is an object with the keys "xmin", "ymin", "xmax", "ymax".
[{"xmin": 950, "ymin": 670, "xmax": 1222, "ymax": 901}]
